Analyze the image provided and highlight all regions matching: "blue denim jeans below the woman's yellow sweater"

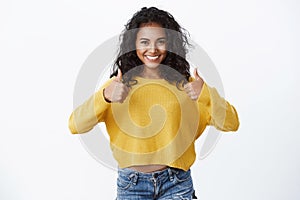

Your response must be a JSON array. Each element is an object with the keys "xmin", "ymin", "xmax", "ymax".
[{"xmin": 117, "ymin": 168, "xmax": 194, "ymax": 200}]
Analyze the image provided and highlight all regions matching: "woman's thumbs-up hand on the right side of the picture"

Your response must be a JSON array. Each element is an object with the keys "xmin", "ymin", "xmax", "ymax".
[{"xmin": 184, "ymin": 69, "xmax": 204, "ymax": 100}]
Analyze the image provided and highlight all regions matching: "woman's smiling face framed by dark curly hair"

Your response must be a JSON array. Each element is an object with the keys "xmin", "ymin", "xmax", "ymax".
[{"xmin": 135, "ymin": 23, "xmax": 167, "ymax": 69}]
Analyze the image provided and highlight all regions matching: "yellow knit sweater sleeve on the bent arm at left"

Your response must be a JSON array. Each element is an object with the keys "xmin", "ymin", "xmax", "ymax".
[{"xmin": 69, "ymin": 79, "xmax": 113, "ymax": 134}]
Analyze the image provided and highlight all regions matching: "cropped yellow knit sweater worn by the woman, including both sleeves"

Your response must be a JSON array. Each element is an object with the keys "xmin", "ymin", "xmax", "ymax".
[{"xmin": 69, "ymin": 77, "xmax": 239, "ymax": 170}]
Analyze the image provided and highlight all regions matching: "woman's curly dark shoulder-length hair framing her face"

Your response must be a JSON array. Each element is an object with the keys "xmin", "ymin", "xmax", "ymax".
[{"xmin": 110, "ymin": 7, "xmax": 191, "ymax": 87}]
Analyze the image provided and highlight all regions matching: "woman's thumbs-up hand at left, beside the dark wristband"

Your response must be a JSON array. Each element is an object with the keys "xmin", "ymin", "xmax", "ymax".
[{"xmin": 103, "ymin": 69, "xmax": 129, "ymax": 103}]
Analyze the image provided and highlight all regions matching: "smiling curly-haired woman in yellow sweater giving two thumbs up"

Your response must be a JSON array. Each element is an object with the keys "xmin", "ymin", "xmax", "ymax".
[{"xmin": 69, "ymin": 7, "xmax": 239, "ymax": 200}]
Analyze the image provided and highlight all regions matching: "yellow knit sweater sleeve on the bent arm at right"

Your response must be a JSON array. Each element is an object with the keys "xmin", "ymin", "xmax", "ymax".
[{"xmin": 198, "ymin": 83, "xmax": 240, "ymax": 131}]
